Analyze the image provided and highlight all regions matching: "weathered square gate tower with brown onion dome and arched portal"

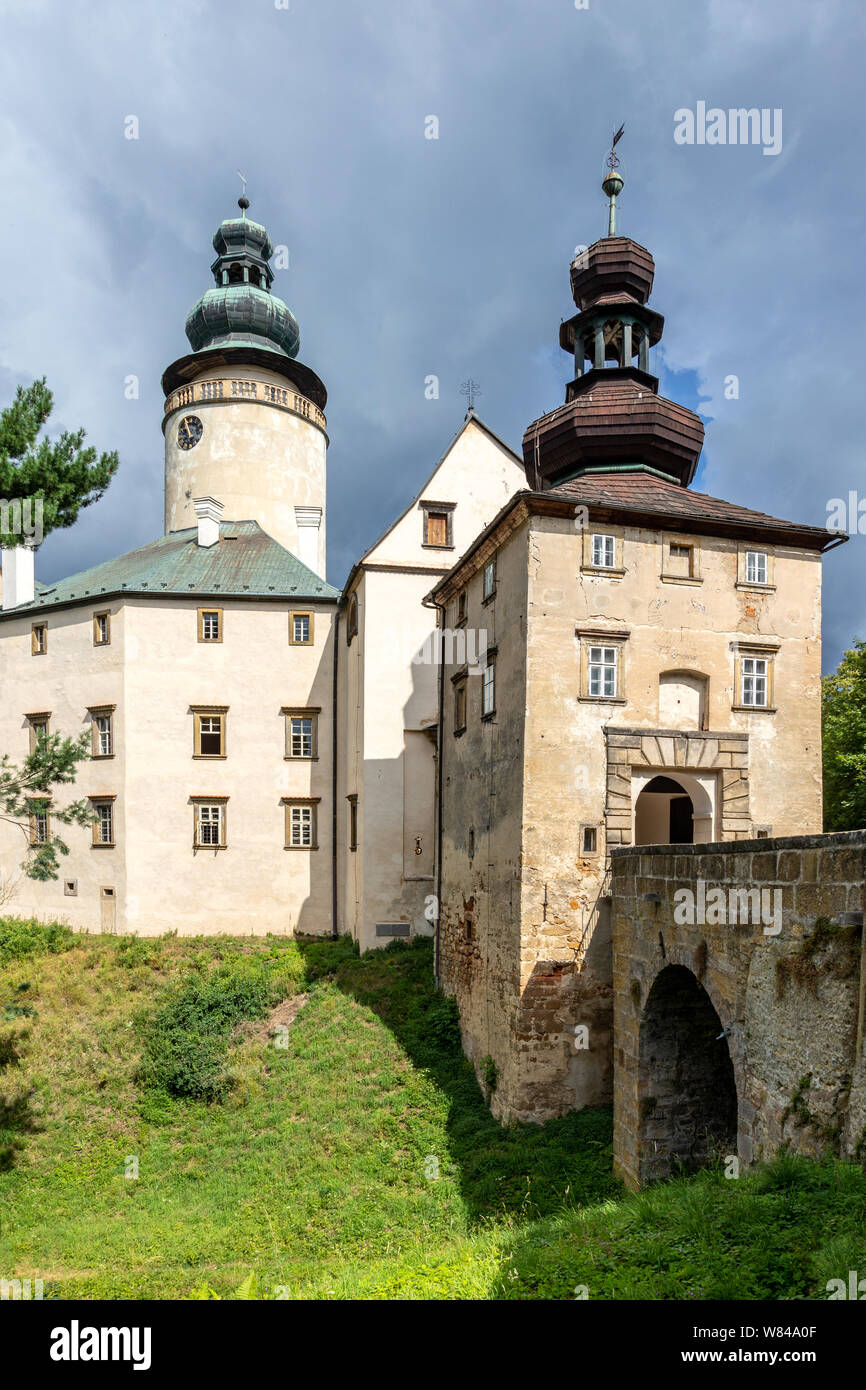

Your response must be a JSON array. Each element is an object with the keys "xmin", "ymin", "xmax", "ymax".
[{"xmin": 431, "ymin": 168, "xmax": 834, "ymax": 1120}]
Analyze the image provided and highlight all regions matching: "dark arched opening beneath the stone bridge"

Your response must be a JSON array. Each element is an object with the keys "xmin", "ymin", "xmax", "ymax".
[{"xmin": 638, "ymin": 965, "xmax": 737, "ymax": 1183}]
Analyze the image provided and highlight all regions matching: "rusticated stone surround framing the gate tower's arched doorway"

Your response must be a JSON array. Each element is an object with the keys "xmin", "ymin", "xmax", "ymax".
[{"xmin": 605, "ymin": 726, "xmax": 752, "ymax": 849}]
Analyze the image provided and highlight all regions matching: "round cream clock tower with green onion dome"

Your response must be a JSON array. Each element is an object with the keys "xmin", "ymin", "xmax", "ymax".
[{"xmin": 163, "ymin": 197, "xmax": 328, "ymax": 577}]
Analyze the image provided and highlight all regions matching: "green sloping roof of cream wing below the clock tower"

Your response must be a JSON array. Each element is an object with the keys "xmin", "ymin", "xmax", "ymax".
[{"xmin": 0, "ymin": 521, "xmax": 339, "ymax": 617}]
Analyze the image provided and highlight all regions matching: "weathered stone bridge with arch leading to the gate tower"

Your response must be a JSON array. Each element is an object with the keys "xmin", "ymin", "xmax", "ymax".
[{"xmin": 610, "ymin": 831, "xmax": 866, "ymax": 1187}]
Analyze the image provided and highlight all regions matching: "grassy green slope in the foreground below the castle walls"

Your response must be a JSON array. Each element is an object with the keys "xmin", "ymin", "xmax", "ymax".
[{"xmin": 0, "ymin": 922, "xmax": 866, "ymax": 1300}]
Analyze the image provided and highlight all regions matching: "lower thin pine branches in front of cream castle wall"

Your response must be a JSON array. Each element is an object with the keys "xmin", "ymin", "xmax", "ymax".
[{"xmin": 0, "ymin": 734, "xmax": 93, "ymax": 880}]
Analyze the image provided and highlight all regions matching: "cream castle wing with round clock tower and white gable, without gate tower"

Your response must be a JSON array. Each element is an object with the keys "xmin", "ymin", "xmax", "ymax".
[{"xmin": 0, "ymin": 199, "xmax": 525, "ymax": 948}]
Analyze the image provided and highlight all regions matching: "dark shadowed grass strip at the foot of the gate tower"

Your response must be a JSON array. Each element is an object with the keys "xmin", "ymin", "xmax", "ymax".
[{"xmin": 297, "ymin": 937, "xmax": 621, "ymax": 1222}]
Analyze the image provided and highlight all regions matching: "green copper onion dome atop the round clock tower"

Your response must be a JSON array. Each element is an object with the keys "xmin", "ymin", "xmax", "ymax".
[{"xmin": 186, "ymin": 197, "xmax": 300, "ymax": 357}]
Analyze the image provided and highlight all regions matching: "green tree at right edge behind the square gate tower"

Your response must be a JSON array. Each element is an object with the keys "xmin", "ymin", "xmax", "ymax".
[{"xmin": 823, "ymin": 638, "xmax": 866, "ymax": 831}]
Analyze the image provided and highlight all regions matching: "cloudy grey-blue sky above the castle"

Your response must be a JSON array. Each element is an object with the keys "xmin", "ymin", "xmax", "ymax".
[{"xmin": 0, "ymin": 0, "xmax": 866, "ymax": 667}]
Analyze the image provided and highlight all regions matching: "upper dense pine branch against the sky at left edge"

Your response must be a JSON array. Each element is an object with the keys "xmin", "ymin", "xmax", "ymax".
[{"xmin": 0, "ymin": 377, "xmax": 118, "ymax": 546}]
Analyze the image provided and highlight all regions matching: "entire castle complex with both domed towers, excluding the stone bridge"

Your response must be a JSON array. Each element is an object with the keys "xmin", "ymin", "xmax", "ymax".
[{"xmin": 0, "ymin": 170, "xmax": 837, "ymax": 1084}]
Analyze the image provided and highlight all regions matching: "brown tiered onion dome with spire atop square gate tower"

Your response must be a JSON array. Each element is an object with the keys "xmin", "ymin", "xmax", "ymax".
[{"xmin": 523, "ymin": 129, "xmax": 703, "ymax": 489}]
